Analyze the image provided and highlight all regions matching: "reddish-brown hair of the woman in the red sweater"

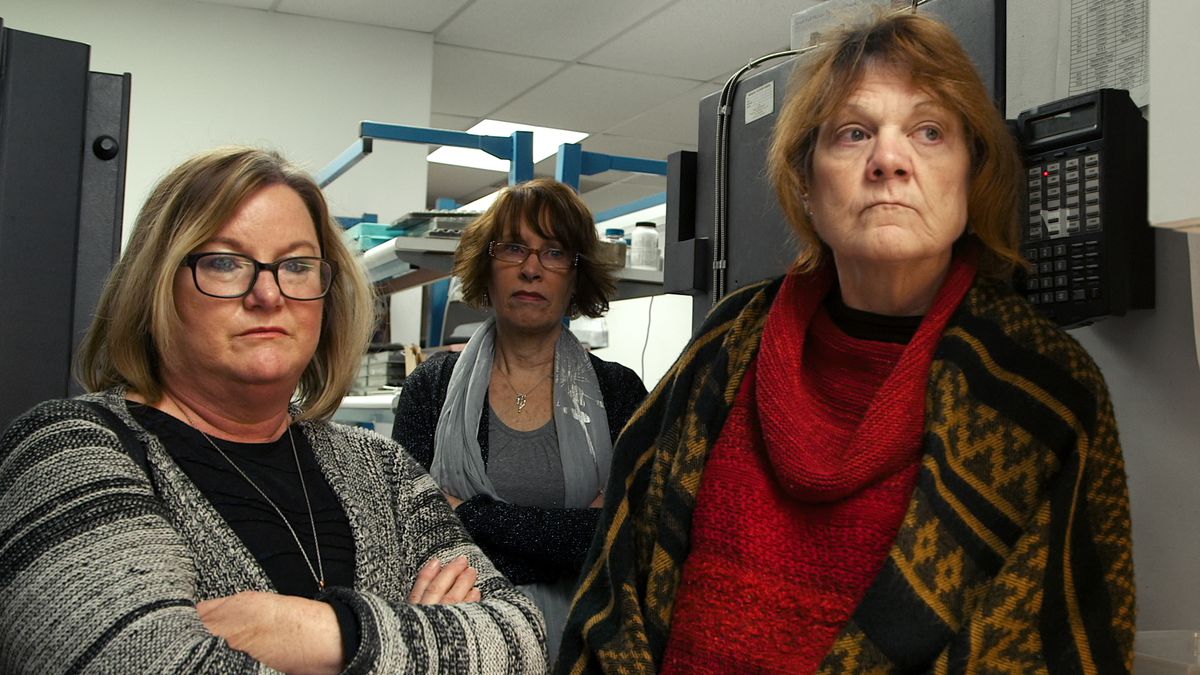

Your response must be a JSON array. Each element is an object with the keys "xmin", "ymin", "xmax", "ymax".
[{"xmin": 768, "ymin": 12, "xmax": 1021, "ymax": 279}]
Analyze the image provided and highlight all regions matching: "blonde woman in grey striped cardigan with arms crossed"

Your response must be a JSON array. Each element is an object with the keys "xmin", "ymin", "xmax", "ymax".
[{"xmin": 0, "ymin": 147, "xmax": 545, "ymax": 673}]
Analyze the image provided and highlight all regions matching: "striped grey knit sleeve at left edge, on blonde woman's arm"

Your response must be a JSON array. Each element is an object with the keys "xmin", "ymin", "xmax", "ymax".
[{"xmin": 0, "ymin": 401, "xmax": 263, "ymax": 673}]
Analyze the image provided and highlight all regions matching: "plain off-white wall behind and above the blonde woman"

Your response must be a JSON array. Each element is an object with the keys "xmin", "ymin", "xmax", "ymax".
[{"xmin": 0, "ymin": 0, "xmax": 433, "ymax": 228}]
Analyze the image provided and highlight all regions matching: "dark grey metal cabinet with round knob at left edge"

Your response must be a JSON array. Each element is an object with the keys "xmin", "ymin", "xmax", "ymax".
[{"xmin": 0, "ymin": 19, "xmax": 130, "ymax": 428}]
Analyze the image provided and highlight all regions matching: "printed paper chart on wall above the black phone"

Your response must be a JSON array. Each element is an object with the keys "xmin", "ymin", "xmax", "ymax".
[{"xmin": 1055, "ymin": 0, "xmax": 1150, "ymax": 107}]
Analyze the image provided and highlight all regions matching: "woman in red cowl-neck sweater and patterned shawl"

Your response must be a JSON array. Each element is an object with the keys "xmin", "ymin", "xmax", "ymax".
[{"xmin": 558, "ymin": 13, "xmax": 1134, "ymax": 673}]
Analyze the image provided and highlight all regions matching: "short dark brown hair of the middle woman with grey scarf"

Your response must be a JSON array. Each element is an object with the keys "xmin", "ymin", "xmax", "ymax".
[{"xmin": 454, "ymin": 178, "xmax": 617, "ymax": 318}]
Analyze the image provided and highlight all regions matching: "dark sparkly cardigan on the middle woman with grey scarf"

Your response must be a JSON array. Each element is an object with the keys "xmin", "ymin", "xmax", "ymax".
[{"xmin": 391, "ymin": 352, "xmax": 646, "ymax": 584}]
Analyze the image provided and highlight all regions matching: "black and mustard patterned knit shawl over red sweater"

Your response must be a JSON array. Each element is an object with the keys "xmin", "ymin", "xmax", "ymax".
[{"xmin": 558, "ymin": 271, "xmax": 1134, "ymax": 674}]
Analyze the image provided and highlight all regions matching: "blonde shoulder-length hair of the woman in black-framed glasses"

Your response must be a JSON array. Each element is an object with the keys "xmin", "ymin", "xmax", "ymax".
[{"xmin": 76, "ymin": 147, "xmax": 374, "ymax": 419}]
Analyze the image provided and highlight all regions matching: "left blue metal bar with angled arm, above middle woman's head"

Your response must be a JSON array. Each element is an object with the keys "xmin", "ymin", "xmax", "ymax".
[{"xmin": 316, "ymin": 120, "xmax": 532, "ymax": 187}]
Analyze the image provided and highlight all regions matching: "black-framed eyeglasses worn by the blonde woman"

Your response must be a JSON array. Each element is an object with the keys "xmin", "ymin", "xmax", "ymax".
[{"xmin": 180, "ymin": 252, "xmax": 337, "ymax": 300}]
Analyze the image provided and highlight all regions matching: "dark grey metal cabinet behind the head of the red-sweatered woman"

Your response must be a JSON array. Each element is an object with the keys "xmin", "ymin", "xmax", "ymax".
[{"xmin": 664, "ymin": 0, "xmax": 1006, "ymax": 330}]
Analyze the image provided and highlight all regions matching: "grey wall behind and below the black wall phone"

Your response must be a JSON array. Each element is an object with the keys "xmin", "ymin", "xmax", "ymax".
[{"xmin": 1007, "ymin": 0, "xmax": 1200, "ymax": 631}]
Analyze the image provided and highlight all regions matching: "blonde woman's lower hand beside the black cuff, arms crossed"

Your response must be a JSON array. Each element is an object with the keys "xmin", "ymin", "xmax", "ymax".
[{"xmin": 196, "ymin": 591, "xmax": 346, "ymax": 673}]
